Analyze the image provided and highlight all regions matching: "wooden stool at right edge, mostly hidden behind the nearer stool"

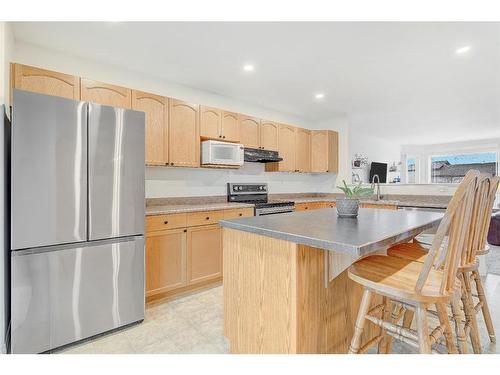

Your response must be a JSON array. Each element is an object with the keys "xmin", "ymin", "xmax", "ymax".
[{"xmin": 387, "ymin": 173, "xmax": 500, "ymax": 354}]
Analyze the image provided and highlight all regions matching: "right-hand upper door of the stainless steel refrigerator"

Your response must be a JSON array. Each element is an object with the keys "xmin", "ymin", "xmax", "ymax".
[{"xmin": 88, "ymin": 103, "xmax": 145, "ymax": 240}]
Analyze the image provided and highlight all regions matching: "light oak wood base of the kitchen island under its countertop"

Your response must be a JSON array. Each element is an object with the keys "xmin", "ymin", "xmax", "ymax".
[{"xmin": 223, "ymin": 228, "xmax": 381, "ymax": 354}]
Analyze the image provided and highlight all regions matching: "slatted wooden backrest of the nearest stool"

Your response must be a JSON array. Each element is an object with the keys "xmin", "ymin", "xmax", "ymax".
[{"xmin": 415, "ymin": 170, "xmax": 479, "ymax": 294}]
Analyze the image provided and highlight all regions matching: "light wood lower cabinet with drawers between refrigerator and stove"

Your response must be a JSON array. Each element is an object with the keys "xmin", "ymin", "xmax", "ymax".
[{"xmin": 146, "ymin": 207, "xmax": 253, "ymax": 300}]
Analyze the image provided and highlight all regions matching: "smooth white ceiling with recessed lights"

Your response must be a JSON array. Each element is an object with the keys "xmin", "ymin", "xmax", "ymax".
[{"xmin": 10, "ymin": 22, "xmax": 500, "ymax": 143}]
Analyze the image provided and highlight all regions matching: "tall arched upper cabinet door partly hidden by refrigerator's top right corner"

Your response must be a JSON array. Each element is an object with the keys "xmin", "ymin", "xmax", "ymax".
[{"xmin": 132, "ymin": 90, "xmax": 168, "ymax": 165}]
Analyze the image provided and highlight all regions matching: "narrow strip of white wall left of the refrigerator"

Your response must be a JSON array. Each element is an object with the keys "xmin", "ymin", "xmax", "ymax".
[{"xmin": 0, "ymin": 22, "xmax": 13, "ymax": 353}]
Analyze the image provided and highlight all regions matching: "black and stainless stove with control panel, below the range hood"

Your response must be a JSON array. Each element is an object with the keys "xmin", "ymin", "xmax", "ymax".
[{"xmin": 227, "ymin": 183, "xmax": 295, "ymax": 216}]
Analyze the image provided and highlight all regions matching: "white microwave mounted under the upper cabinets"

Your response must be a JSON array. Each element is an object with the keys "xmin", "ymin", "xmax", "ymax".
[{"xmin": 201, "ymin": 141, "xmax": 245, "ymax": 165}]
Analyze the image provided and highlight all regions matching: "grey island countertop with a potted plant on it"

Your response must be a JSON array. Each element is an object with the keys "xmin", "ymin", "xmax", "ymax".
[{"xmin": 219, "ymin": 208, "xmax": 443, "ymax": 257}]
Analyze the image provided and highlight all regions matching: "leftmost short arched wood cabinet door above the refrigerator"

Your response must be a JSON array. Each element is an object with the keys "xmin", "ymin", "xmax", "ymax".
[{"xmin": 11, "ymin": 64, "xmax": 80, "ymax": 100}]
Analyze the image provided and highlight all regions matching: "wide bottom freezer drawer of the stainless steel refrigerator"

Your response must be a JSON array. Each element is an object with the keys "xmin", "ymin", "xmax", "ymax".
[{"xmin": 11, "ymin": 237, "xmax": 144, "ymax": 353}]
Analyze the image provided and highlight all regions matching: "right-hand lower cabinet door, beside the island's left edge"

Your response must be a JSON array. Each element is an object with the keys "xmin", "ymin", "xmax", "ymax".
[{"xmin": 187, "ymin": 224, "xmax": 222, "ymax": 284}]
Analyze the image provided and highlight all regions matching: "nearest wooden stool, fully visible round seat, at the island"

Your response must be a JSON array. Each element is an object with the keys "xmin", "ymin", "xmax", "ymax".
[{"xmin": 348, "ymin": 171, "xmax": 479, "ymax": 353}]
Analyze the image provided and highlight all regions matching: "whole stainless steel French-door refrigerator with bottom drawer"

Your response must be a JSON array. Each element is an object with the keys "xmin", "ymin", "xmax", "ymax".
[{"xmin": 11, "ymin": 90, "xmax": 145, "ymax": 353}]
